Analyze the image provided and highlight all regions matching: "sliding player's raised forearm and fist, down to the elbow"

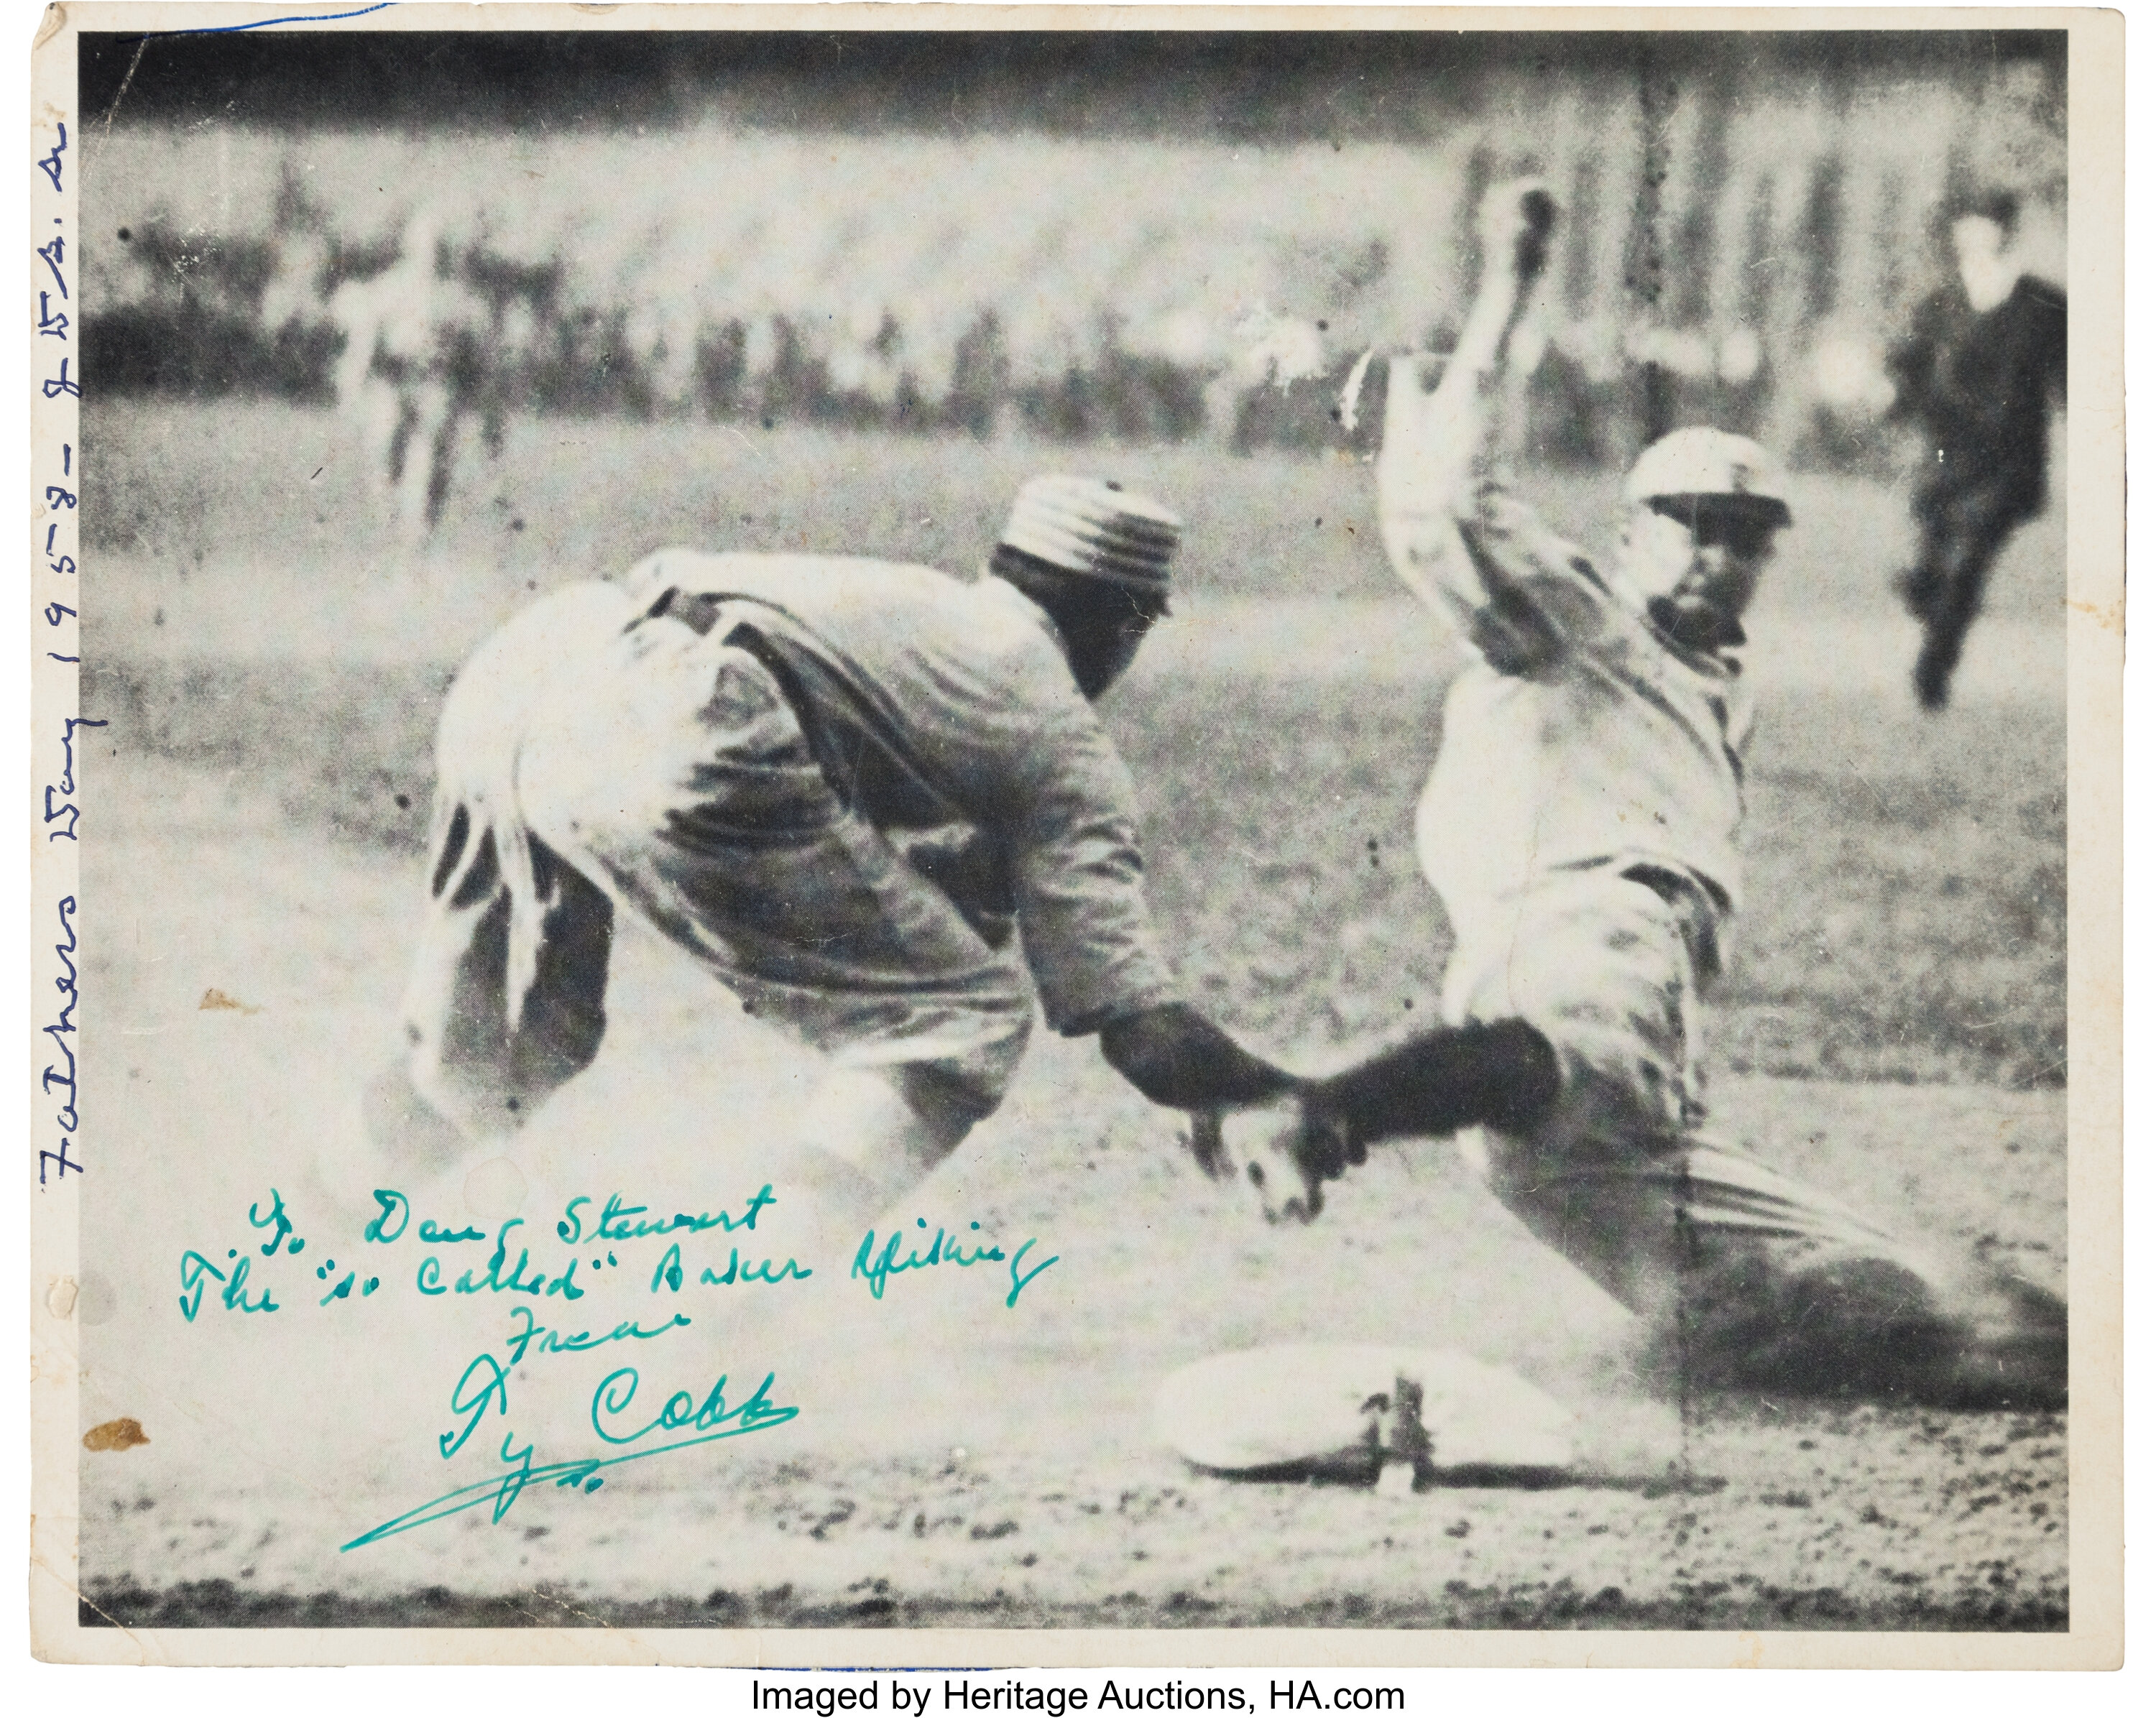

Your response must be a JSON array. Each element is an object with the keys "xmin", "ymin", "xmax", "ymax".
[{"xmin": 1378, "ymin": 179, "xmax": 1557, "ymax": 619}]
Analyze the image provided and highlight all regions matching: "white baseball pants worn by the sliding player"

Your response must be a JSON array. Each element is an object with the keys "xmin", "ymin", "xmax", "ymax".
[{"xmin": 1445, "ymin": 869, "xmax": 1908, "ymax": 1324}]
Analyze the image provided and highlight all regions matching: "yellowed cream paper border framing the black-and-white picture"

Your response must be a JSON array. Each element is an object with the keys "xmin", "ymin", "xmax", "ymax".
[{"xmin": 28, "ymin": 4, "xmax": 2124, "ymax": 1668}]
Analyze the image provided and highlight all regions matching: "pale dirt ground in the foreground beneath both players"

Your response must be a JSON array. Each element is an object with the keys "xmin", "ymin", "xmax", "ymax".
[{"xmin": 82, "ymin": 785, "xmax": 2065, "ymax": 1627}]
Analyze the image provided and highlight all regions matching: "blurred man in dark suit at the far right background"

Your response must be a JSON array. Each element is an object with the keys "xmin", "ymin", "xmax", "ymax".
[{"xmin": 1886, "ymin": 192, "xmax": 2065, "ymax": 709}]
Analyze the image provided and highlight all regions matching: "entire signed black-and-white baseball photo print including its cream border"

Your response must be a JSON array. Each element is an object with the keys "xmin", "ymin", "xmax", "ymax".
[{"xmin": 30, "ymin": 4, "xmax": 2124, "ymax": 1664}]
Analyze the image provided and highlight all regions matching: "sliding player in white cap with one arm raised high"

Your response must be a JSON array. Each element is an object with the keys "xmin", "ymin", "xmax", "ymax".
[{"xmin": 1194, "ymin": 185, "xmax": 2065, "ymax": 1405}]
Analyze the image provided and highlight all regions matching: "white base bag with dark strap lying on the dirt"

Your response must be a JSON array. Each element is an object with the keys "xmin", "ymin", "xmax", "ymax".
[{"xmin": 1153, "ymin": 1343, "xmax": 1574, "ymax": 1490}]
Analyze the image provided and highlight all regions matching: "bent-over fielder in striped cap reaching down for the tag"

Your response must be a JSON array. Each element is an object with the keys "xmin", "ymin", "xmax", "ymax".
[{"xmin": 369, "ymin": 476, "xmax": 1287, "ymax": 1222}]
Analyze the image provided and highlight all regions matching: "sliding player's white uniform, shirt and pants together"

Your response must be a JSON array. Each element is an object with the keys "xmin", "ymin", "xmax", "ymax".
[{"xmin": 1378, "ymin": 349, "xmax": 1932, "ymax": 1313}]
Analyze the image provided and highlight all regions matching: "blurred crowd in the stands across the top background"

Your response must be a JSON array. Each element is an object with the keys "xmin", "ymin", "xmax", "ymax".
[{"xmin": 80, "ymin": 32, "xmax": 2065, "ymax": 530}]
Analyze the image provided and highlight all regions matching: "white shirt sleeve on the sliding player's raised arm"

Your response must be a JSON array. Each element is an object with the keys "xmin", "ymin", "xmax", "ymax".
[{"xmin": 1378, "ymin": 351, "xmax": 1613, "ymax": 679}]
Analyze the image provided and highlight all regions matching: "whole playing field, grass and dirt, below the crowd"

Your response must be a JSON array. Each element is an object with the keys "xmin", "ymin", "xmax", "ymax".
[{"xmin": 80, "ymin": 418, "xmax": 2068, "ymax": 1630}]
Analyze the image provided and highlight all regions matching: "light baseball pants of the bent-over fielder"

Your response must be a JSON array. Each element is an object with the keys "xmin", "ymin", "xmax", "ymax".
[{"xmin": 405, "ymin": 586, "xmax": 1033, "ymax": 1142}]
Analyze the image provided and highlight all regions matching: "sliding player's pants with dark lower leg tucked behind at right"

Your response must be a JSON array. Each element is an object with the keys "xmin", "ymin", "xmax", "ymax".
[{"xmin": 1449, "ymin": 875, "xmax": 2065, "ymax": 1405}]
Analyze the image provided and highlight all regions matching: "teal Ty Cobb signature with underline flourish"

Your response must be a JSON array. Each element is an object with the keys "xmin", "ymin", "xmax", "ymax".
[{"xmin": 338, "ymin": 1362, "xmax": 800, "ymax": 1552}]
